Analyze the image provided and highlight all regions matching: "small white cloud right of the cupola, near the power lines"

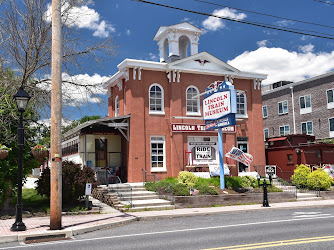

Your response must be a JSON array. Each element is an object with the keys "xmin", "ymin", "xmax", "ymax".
[{"xmin": 202, "ymin": 8, "xmax": 247, "ymax": 31}]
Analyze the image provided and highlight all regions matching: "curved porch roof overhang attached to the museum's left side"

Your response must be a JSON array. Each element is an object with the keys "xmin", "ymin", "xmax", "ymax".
[{"xmin": 63, "ymin": 115, "xmax": 131, "ymax": 141}]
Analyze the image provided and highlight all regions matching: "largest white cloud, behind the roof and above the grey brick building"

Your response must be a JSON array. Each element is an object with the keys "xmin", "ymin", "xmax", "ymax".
[{"xmin": 228, "ymin": 47, "xmax": 334, "ymax": 85}]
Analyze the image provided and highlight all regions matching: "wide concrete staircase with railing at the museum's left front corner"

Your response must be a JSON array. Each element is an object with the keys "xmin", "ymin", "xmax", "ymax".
[{"xmin": 108, "ymin": 182, "xmax": 175, "ymax": 211}]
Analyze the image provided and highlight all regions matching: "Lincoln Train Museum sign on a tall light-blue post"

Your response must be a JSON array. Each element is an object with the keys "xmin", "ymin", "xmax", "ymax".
[{"xmin": 203, "ymin": 82, "xmax": 237, "ymax": 189}]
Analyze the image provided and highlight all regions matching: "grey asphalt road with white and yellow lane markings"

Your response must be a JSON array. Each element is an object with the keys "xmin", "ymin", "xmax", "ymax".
[{"xmin": 0, "ymin": 207, "xmax": 334, "ymax": 250}]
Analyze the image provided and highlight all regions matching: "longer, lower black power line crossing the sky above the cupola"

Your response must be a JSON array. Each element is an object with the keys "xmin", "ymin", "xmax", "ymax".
[{"xmin": 131, "ymin": 0, "xmax": 334, "ymax": 40}]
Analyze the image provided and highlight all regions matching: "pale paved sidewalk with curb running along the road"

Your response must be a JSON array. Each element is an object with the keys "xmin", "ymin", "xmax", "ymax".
[{"xmin": 0, "ymin": 200, "xmax": 334, "ymax": 243}]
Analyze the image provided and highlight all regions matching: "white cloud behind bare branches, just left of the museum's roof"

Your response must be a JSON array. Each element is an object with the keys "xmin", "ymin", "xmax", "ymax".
[{"xmin": 39, "ymin": 73, "xmax": 109, "ymax": 106}]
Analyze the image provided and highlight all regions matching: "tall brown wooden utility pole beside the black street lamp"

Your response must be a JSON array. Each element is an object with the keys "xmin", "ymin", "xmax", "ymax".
[{"xmin": 50, "ymin": 0, "xmax": 62, "ymax": 230}]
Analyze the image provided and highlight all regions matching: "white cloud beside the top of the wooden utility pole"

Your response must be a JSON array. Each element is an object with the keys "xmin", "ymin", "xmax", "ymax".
[{"xmin": 45, "ymin": 1, "xmax": 116, "ymax": 37}]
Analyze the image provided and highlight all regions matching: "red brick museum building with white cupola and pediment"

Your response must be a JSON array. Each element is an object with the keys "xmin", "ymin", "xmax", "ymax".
[{"xmin": 105, "ymin": 23, "xmax": 266, "ymax": 182}]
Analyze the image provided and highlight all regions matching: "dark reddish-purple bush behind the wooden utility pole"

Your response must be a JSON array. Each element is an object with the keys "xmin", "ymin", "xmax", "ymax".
[{"xmin": 36, "ymin": 161, "xmax": 95, "ymax": 204}]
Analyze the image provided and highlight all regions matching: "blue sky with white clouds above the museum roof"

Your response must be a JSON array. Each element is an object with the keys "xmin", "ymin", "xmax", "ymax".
[{"xmin": 54, "ymin": 0, "xmax": 334, "ymax": 118}]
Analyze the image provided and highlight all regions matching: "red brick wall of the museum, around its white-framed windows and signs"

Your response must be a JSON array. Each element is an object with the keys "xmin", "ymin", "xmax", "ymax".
[{"xmin": 109, "ymin": 69, "xmax": 265, "ymax": 182}]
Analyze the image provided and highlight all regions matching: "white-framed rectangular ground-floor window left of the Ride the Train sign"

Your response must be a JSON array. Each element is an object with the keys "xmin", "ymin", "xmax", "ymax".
[{"xmin": 151, "ymin": 136, "xmax": 166, "ymax": 172}]
